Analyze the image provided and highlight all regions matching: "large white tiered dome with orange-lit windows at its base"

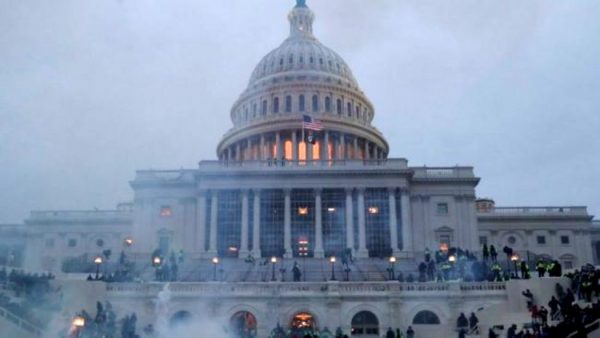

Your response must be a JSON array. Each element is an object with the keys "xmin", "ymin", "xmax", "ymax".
[{"xmin": 217, "ymin": 0, "xmax": 389, "ymax": 162}]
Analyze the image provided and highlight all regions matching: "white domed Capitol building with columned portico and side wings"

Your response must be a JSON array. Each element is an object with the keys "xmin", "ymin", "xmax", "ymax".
[{"xmin": 0, "ymin": 1, "xmax": 600, "ymax": 337}]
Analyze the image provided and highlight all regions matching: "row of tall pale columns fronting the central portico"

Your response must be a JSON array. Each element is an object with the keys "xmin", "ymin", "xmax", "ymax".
[{"xmin": 196, "ymin": 188, "xmax": 413, "ymax": 258}]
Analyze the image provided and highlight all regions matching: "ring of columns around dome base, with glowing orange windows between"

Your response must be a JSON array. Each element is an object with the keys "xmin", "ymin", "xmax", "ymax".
[{"xmin": 220, "ymin": 130, "xmax": 386, "ymax": 162}]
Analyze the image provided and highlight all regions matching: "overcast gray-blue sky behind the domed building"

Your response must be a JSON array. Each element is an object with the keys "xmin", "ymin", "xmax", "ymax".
[{"xmin": 0, "ymin": 0, "xmax": 600, "ymax": 223}]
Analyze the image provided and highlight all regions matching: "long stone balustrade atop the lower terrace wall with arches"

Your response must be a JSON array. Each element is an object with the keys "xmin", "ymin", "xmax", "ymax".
[{"xmin": 107, "ymin": 282, "xmax": 506, "ymax": 297}]
